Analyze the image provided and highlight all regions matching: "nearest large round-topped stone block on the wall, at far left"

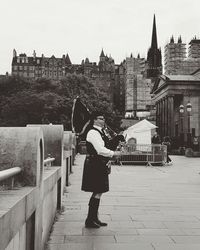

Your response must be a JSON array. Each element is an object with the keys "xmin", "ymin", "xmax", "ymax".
[{"xmin": 0, "ymin": 127, "xmax": 44, "ymax": 186}]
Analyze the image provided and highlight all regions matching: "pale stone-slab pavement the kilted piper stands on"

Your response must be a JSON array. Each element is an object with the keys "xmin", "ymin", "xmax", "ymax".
[{"xmin": 46, "ymin": 155, "xmax": 200, "ymax": 250}]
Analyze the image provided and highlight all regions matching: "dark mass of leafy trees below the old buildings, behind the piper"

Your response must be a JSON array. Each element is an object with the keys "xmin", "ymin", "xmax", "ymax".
[{"xmin": 0, "ymin": 74, "xmax": 118, "ymax": 130}]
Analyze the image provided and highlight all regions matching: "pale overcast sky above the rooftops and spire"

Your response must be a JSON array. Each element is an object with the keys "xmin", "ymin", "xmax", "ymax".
[{"xmin": 0, "ymin": 0, "xmax": 200, "ymax": 74}]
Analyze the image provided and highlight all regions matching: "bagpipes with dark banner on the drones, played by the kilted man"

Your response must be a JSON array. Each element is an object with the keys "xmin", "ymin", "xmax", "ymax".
[{"xmin": 71, "ymin": 96, "xmax": 125, "ymax": 150}]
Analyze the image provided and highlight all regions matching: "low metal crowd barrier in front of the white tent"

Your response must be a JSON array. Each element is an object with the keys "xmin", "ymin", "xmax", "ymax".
[{"xmin": 119, "ymin": 144, "xmax": 167, "ymax": 165}]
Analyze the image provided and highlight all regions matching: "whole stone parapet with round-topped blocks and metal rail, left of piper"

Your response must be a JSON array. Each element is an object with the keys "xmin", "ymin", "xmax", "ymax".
[{"xmin": 0, "ymin": 124, "xmax": 76, "ymax": 250}]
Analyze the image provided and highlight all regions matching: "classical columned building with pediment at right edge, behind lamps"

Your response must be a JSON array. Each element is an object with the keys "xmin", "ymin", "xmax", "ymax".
[{"xmin": 152, "ymin": 71, "xmax": 200, "ymax": 148}]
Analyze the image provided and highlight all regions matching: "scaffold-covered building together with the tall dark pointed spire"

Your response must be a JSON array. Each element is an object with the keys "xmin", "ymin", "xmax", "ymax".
[{"xmin": 125, "ymin": 15, "xmax": 162, "ymax": 118}]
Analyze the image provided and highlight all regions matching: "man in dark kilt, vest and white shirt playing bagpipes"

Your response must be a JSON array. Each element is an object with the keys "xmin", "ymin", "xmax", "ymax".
[{"xmin": 81, "ymin": 112, "xmax": 120, "ymax": 228}]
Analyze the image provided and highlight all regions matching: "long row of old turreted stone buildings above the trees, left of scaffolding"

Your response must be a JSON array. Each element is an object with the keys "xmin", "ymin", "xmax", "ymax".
[{"xmin": 12, "ymin": 49, "xmax": 122, "ymax": 112}]
